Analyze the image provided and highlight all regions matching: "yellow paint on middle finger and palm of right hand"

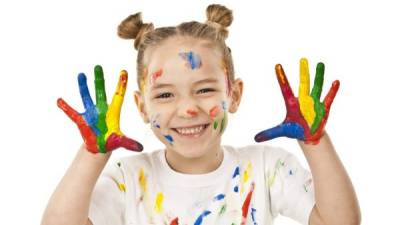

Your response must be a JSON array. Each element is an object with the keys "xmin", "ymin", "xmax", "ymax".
[{"xmin": 299, "ymin": 58, "xmax": 315, "ymax": 127}]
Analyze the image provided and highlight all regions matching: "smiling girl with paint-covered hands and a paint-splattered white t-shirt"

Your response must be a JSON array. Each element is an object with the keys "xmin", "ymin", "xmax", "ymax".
[{"xmin": 42, "ymin": 5, "xmax": 360, "ymax": 225}]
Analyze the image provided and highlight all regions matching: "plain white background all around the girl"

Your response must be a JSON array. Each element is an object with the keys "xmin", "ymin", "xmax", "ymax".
[{"xmin": 0, "ymin": 0, "xmax": 400, "ymax": 225}]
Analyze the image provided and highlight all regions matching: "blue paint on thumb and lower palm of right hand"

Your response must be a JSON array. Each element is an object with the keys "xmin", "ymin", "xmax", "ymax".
[{"xmin": 254, "ymin": 122, "xmax": 304, "ymax": 142}]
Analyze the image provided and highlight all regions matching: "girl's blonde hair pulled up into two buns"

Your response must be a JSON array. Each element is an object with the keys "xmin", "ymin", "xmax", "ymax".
[{"xmin": 118, "ymin": 4, "xmax": 234, "ymax": 91}]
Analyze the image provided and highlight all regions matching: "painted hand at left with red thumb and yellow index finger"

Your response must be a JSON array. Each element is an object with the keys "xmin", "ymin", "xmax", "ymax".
[{"xmin": 57, "ymin": 66, "xmax": 143, "ymax": 153}]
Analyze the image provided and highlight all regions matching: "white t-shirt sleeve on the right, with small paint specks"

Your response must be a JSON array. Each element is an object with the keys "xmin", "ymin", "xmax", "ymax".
[{"xmin": 266, "ymin": 148, "xmax": 315, "ymax": 225}]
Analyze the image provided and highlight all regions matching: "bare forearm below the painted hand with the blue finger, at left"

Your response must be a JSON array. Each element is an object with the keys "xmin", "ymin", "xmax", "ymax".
[{"xmin": 41, "ymin": 146, "xmax": 111, "ymax": 225}]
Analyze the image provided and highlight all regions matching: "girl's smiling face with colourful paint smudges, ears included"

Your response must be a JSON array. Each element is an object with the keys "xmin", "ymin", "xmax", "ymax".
[{"xmin": 135, "ymin": 37, "xmax": 242, "ymax": 158}]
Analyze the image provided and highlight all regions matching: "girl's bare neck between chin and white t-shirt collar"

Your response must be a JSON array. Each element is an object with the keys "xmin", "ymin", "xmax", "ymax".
[{"xmin": 166, "ymin": 146, "xmax": 224, "ymax": 174}]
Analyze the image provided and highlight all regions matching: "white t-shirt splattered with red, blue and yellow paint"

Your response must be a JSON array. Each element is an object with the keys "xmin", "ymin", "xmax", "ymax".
[{"xmin": 89, "ymin": 145, "xmax": 315, "ymax": 225}]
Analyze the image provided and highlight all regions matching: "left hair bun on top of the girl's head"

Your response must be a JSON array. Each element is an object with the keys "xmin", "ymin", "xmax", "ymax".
[{"xmin": 118, "ymin": 12, "xmax": 154, "ymax": 49}]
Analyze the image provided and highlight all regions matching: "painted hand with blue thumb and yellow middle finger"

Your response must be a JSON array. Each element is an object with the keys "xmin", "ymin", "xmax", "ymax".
[{"xmin": 254, "ymin": 58, "xmax": 340, "ymax": 144}]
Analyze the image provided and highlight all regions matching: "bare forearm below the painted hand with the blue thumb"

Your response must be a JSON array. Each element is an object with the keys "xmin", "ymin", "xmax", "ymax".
[{"xmin": 298, "ymin": 133, "xmax": 361, "ymax": 225}]
